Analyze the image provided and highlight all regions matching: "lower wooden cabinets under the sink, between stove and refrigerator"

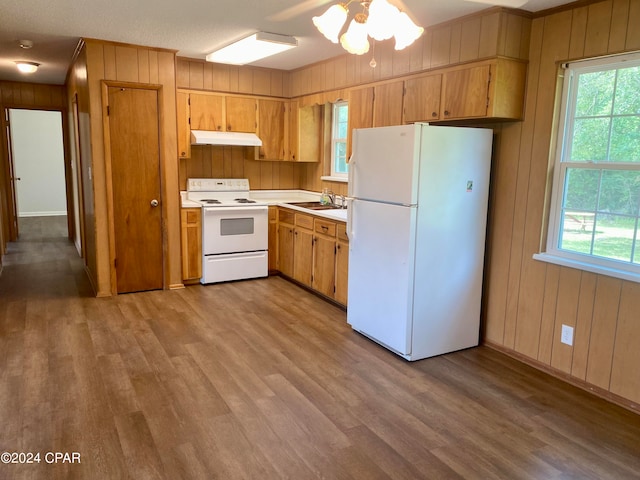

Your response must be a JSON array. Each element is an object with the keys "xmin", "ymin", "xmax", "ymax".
[{"xmin": 277, "ymin": 208, "xmax": 349, "ymax": 305}]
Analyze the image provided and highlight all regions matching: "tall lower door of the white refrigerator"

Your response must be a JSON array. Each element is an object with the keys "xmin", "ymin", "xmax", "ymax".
[{"xmin": 347, "ymin": 199, "xmax": 417, "ymax": 356}]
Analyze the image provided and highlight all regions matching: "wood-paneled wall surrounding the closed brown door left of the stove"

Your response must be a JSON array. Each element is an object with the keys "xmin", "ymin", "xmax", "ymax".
[{"xmin": 68, "ymin": 39, "xmax": 182, "ymax": 296}]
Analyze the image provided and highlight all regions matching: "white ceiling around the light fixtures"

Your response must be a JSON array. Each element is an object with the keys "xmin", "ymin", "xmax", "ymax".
[{"xmin": 0, "ymin": 0, "xmax": 569, "ymax": 84}]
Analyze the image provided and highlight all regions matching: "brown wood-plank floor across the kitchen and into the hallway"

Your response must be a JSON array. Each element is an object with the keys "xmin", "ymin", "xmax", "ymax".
[{"xmin": 0, "ymin": 219, "xmax": 640, "ymax": 480}]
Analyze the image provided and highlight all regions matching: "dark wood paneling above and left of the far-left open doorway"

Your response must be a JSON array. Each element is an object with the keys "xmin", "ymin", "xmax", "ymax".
[{"xmin": 0, "ymin": 81, "xmax": 68, "ymax": 269}]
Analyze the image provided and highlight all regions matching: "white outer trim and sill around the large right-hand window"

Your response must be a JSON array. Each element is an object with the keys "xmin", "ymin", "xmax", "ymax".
[{"xmin": 533, "ymin": 53, "xmax": 640, "ymax": 283}]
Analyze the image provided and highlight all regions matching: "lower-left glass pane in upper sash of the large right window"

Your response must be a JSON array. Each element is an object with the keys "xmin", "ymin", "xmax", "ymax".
[{"xmin": 571, "ymin": 117, "xmax": 611, "ymax": 162}]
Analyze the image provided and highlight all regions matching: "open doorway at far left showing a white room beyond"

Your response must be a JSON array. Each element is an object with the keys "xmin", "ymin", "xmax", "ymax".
[{"xmin": 8, "ymin": 108, "xmax": 70, "ymax": 240}]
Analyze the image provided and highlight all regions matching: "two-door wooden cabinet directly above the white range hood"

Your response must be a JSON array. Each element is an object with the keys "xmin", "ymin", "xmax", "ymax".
[{"xmin": 189, "ymin": 93, "xmax": 258, "ymax": 133}]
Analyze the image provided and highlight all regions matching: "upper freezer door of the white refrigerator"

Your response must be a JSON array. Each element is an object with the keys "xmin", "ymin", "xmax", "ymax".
[{"xmin": 348, "ymin": 125, "xmax": 421, "ymax": 205}]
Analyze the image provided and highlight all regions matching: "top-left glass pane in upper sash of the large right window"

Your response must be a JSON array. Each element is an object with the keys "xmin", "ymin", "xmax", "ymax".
[{"xmin": 576, "ymin": 70, "xmax": 616, "ymax": 117}]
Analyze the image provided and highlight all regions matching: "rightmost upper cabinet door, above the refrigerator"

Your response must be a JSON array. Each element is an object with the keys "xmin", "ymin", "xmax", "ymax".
[{"xmin": 440, "ymin": 65, "xmax": 491, "ymax": 120}]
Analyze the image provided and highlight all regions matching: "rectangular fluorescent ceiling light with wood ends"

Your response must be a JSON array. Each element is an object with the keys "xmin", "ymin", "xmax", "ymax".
[{"xmin": 206, "ymin": 32, "xmax": 298, "ymax": 65}]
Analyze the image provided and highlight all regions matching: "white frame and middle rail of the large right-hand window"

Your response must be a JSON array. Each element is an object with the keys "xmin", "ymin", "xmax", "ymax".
[{"xmin": 534, "ymin": 53, "xmax": 640, "ymax": 283}]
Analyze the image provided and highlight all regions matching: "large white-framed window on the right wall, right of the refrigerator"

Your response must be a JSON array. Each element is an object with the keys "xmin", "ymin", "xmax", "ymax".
[{"xmin": 535, "ymin": 54, "xmax": 640, "ymax": 282}]
